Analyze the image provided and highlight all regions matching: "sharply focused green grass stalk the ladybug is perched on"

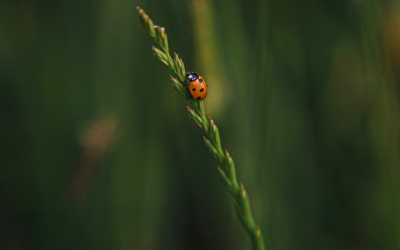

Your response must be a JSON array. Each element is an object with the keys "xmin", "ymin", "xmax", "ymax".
[{"xmin": 136, "ymin": 7, "xmax": 264, "ymax": 250}]
